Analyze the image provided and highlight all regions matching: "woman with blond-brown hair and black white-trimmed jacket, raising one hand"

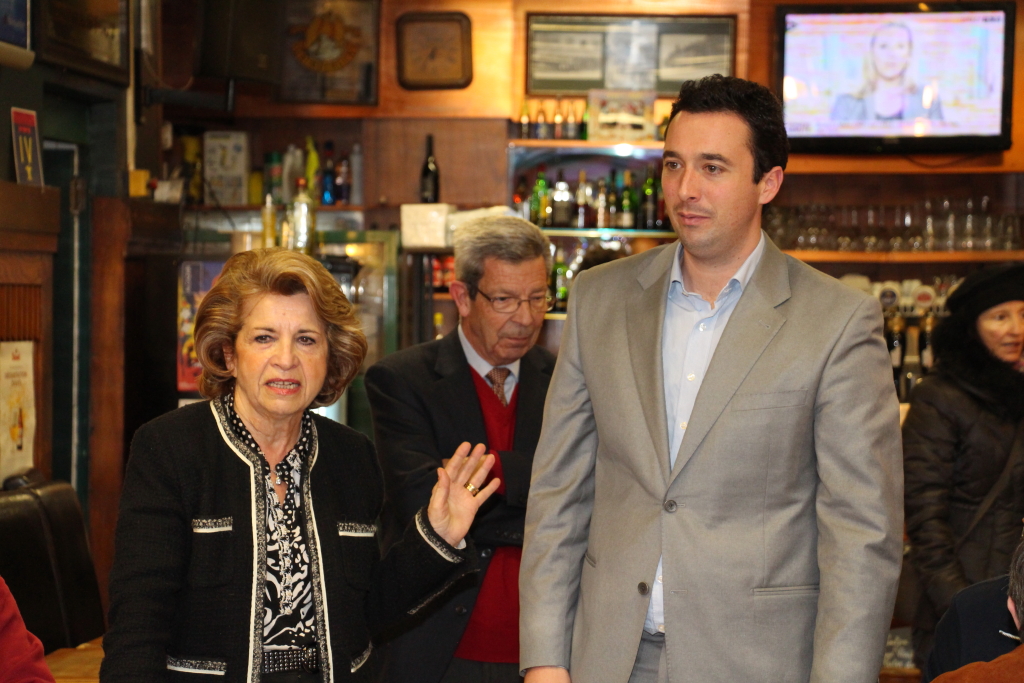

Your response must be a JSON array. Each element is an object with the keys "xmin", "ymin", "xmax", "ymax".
[{"xmin": 100, "ymin": 249, "xmax": 500, "ymax": 683}]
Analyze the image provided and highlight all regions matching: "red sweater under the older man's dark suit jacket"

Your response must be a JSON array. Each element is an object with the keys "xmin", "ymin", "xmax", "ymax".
[{"xmin": 455, "ymin": 370, "xmax": 522, "ymax": 664}]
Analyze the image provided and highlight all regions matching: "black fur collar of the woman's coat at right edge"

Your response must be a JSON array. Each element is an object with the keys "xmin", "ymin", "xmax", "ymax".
[{"xmin": 934, "ymin": 314, "xmax": 1024, "ymax": 421}]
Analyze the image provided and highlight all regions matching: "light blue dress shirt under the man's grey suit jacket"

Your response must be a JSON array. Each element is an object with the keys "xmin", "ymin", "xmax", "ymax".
[{"xmin": 643, "ymin": 232, "xmax": 765, "ymax": 633}]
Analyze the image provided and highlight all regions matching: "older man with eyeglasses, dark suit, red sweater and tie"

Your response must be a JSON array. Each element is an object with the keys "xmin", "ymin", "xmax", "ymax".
[{"xmin": 366, "ymin": 217, "xmax": 555, "ymax": 683}]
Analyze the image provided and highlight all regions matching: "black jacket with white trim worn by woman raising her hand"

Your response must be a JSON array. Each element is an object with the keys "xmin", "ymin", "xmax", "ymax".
[{"xmin": 100, "ymin": 400, "xmax": 475, "ymax": 683}]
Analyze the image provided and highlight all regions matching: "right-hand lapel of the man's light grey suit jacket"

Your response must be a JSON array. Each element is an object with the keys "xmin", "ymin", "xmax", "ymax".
[{"xmin": 670, "ymin": 241, "xmax": 790, "ymax": 485}]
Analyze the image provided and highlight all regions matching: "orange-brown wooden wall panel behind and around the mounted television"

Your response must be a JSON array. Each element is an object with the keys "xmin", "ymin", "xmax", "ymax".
[{"xmin": 748, "ymin": 0, "xmax": 1024, "ymax": 174}]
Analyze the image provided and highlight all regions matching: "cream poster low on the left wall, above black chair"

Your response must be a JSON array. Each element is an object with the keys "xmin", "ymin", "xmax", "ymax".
[{"xmin": 0, "ymin": 341, "xmax": 36, "ymax": 481}]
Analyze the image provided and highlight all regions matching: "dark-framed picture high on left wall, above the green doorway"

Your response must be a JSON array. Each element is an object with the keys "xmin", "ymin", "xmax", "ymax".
[{"xmin": 35, "ymin": 0, "xmax": 129, "ymax": 85}]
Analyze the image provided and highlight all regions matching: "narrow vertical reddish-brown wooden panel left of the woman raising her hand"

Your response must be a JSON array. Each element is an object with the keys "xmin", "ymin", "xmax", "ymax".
[{"xmin": 89, "ymin": 197, "xmax": 131, "ymax": 606}]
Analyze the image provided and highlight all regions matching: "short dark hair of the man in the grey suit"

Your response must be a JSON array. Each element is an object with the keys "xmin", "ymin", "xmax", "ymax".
[{"xmin": 669, "ymin": 74, "xmax": 790, "ymax": 183}]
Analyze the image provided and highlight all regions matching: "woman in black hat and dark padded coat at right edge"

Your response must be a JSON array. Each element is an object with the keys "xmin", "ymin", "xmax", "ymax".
[{"xmin": 903, "ymin": 264, "xmax": 1024, "ymax": 668}]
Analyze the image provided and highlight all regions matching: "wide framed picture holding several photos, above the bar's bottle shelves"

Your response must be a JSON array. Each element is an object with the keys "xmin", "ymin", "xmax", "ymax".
[{"xmin": 526, "ymin": 14, "xmax": 736, "ymax": 97}]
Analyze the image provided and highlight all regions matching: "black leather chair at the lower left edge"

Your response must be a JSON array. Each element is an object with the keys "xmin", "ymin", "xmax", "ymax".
[{"xmin": 0, "ymin": 476, "xmax": 105, "ymax": 652}]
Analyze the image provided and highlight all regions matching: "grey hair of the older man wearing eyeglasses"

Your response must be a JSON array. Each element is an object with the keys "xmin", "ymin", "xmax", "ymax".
[{"xmin": 455, "ymin": 216, "xmax": 551, "ymax": 298}]
